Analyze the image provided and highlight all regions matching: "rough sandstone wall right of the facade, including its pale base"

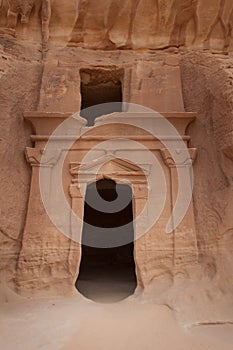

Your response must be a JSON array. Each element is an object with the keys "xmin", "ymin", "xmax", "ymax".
[{"xmin": 154, "ymin": 52, "xmax": 233, "ymax": 322}]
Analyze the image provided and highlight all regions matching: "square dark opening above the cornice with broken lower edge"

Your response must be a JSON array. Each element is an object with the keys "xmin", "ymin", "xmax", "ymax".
[{"xmin": 80, "ymin": 68, "xmax": 123, "ymax": 126}]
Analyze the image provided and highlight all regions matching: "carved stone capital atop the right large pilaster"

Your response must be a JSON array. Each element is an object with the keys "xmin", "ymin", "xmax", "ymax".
[{"xmin": 160, "ymin": 148, "xmax": 197, "ymax": 167}]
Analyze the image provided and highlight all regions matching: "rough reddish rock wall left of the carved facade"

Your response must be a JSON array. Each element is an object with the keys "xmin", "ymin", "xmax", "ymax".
[{"xmin": 0, "ymin": 41, "xmax": 41, "ymax": 288}]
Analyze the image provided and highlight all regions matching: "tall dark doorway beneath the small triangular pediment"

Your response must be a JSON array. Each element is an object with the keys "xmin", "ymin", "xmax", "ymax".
[{"xmin": 75, "ymin": 179, "xmax": 137, "ymax": 302}]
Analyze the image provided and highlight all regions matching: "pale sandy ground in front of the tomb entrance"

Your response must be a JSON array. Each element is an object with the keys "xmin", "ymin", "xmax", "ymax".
[{"xmin": 0, "ymin": 290, "xmax": 233, "ymax": 350}]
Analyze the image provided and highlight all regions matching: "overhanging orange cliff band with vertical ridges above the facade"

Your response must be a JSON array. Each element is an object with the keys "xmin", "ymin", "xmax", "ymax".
[{"xmin": 0, "ymin": 0, "xmax": 233, "ymax": 51}]
